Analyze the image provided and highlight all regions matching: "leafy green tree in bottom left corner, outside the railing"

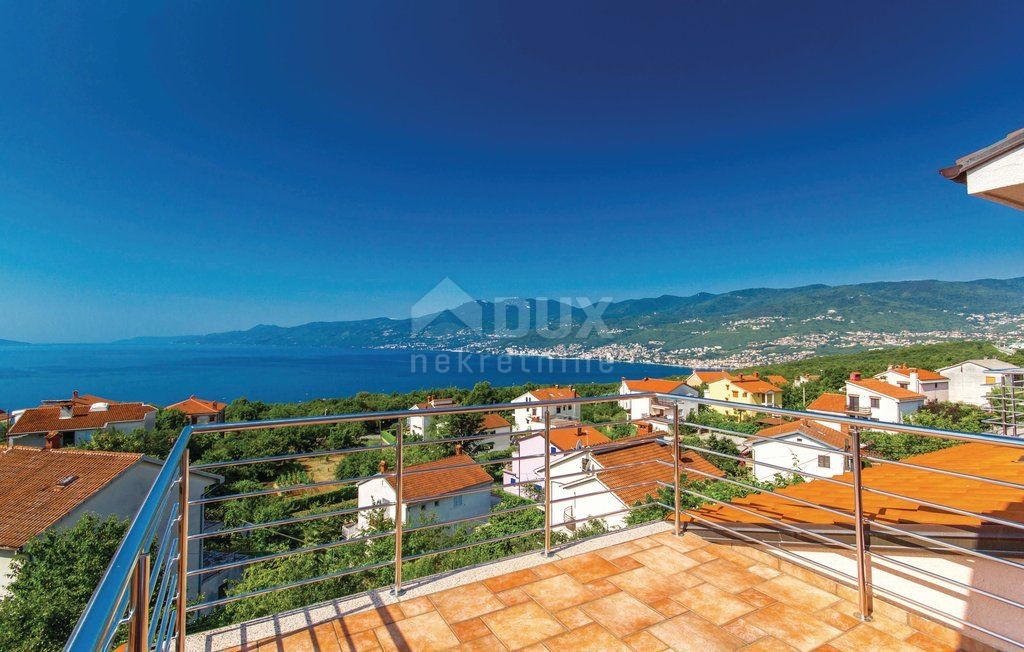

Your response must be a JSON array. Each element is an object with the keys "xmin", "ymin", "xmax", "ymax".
[{"xmin": 0, "ymin": 514, "xmax": 127, "ymax": 652}]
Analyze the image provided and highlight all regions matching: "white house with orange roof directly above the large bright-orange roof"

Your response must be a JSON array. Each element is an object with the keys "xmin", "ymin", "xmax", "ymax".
[{"xmin": 743, "ymin": 419, "xmax": 850, "ymax": 481}]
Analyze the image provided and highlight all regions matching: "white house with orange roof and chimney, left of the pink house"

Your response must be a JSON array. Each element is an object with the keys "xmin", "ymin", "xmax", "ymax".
[{"xmin": 358, "ymin": 445, "xmax": 495, "ymax": 529}]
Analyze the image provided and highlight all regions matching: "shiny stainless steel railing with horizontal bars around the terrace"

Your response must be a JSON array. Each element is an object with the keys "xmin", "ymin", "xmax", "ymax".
[{"xmin": 67, "ymin": 392, "xmax": 1024, "ymax": 651}]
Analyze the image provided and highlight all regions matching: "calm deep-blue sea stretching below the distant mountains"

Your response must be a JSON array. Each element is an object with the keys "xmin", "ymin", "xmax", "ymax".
[{"xmin": 0, "ymin": 344, "xmax": 689, "ymax": 410}]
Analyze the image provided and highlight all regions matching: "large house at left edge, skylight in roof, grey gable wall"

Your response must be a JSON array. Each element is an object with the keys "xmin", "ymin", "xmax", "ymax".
[{"xmin": 0, "ymin": 446, "xmax": 221, "ymax": 598}]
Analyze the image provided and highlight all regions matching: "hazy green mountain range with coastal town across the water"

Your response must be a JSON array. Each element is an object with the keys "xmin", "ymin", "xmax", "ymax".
[{"xmin": 116, "ymin": 277, "xmax": 1024, "ymax": 365}]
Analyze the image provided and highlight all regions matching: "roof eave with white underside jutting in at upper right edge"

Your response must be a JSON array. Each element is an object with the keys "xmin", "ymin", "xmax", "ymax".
[{"xmin": 939, "ymin": 129, "xmax": 1024, "ymax": 210}]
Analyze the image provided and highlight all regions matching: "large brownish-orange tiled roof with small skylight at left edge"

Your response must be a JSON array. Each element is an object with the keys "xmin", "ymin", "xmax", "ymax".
[{"xmin": 0, "ymin": 446, "xmax": 142, "ymax": 550}]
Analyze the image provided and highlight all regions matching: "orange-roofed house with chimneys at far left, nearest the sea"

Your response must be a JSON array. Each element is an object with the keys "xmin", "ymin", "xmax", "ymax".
[{"xmin": 7, "ymin": 392, "xmax": 157, "ymax": 448}]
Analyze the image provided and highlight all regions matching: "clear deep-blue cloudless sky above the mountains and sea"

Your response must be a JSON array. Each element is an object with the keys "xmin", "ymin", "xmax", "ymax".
[{"xmin": 0, "ymin": 1, "xmax": 1024, "ymax": 342}]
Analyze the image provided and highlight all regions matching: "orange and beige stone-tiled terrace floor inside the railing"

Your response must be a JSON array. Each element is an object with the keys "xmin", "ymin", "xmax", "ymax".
[{"xmin": 204, "ymin": 531, "xmax": 966, "ymax": 652}]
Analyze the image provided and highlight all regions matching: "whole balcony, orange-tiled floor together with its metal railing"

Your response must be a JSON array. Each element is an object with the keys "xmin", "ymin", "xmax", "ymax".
[{"xmin": 67, "ymin": 394, "xmax": 1024, "ymax": 651}]
